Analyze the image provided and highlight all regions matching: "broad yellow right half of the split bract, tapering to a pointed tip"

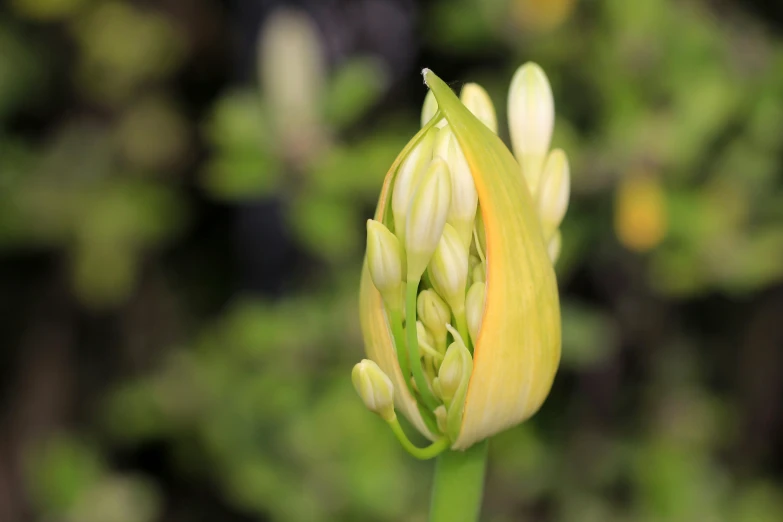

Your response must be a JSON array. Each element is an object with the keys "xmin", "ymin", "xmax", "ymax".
[{"xmin": 424, "ymin": 70, "xmax": 561, "ymax": 449}]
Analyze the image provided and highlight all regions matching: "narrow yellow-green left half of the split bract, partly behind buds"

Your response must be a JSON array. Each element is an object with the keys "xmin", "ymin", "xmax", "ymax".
[{"xmin": 359, "ymin": 122, "xmax": 437, "ymax": 440}]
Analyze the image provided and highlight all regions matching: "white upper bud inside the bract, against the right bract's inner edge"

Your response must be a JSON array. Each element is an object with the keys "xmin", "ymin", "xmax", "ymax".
[{"xmin": 446, "ymin": 137, "xmax": 478, "ymax": 248}]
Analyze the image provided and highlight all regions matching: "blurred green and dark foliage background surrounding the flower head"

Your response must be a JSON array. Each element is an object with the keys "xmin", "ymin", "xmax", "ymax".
[{"xmin": 0, "ymin": 0, "xmax": 783, "ymax": 522}]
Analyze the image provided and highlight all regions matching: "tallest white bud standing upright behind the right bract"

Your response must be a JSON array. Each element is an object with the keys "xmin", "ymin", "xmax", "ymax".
[{"xmin": 508, "ymin": 62, "xmax": 555, "ymax": 194}]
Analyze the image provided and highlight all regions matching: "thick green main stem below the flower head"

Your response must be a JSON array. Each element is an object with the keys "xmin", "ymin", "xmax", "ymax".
[{"xmin": 430, "ymin": 441, "xmax": 489, "ymax": 522}]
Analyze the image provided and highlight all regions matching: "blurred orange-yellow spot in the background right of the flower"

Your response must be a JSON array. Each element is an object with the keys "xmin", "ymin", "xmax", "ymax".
[{"xmin": 614, "ymin": 174, "xmax": 667, "ymax": 252}]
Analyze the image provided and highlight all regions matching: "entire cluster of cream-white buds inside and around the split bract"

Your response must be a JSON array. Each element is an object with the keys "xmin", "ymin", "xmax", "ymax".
[{"xmin": 354, "ymin": 64, "xmax": 570, "ymax": 445}]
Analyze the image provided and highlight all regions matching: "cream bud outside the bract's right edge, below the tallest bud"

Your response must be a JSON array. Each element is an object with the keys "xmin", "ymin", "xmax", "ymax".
[{"xmin": 540, "ymin": 149, "xmax": 571, "ymax": 240}]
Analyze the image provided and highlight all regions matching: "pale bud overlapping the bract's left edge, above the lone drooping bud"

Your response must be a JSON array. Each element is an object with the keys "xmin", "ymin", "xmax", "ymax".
[{"xmin": 367, "ymin": 219, "xmax": 402, "ymax": 309}]
